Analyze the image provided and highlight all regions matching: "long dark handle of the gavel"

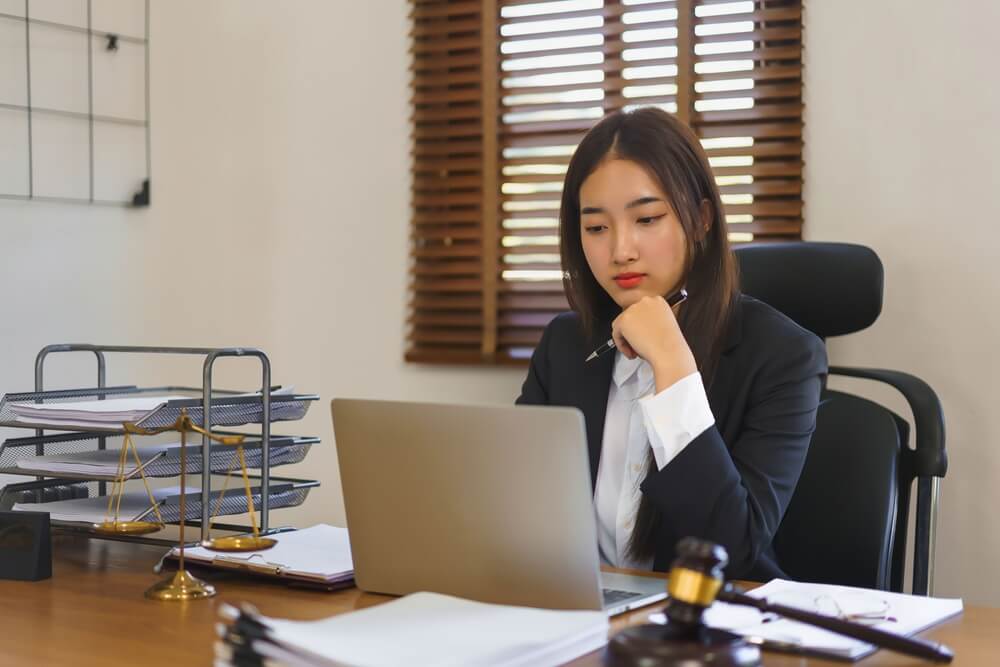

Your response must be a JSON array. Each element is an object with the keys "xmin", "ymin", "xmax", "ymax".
[{"xmin": 716, "ymin": 585, "xmax": 955, "ymax": 662}]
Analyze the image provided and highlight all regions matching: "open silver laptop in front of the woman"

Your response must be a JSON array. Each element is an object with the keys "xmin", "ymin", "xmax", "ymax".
[{"xmin": 331, "ymin": 399, "xmax": 666, "ymax": 614}]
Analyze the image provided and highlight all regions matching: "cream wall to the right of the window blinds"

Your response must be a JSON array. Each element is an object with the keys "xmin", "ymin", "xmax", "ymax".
[{"xmin": 805, "ymin": 0, "xmax": 1000, "ymax": 605}]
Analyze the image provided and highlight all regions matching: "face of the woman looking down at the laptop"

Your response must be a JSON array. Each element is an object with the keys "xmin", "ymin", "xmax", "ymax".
[{"xmin": 580, "ymin": 158, "xmax": 687, "ymax": 310}]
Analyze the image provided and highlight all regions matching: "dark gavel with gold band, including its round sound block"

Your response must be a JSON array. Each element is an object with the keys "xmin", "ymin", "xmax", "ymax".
[{"xmin": 608, "ymin": 537, "xmax": 954, "ymax": 667}]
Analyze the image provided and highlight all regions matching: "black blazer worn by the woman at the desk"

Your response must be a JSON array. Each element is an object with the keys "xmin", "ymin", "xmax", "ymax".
[{"xmin": 517, "ymin": 295, "xmax": 827, "ymax": 581}]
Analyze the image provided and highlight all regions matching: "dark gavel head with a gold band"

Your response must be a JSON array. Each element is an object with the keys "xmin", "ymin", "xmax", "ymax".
[{"xmin": 664, "ymin": 537, "xmax": 729, "ymax": 629}]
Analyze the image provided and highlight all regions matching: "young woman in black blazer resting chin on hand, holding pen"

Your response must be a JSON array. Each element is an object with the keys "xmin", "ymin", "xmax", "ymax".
[{"xmin": 517, "ymin": 108, "xmax": 827, "ymax": 580}]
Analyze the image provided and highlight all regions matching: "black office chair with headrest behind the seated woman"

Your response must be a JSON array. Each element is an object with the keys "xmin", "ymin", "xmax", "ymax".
[{"xmin": 736, "ymin": 242, "xmax": 948, "ymax": 595}]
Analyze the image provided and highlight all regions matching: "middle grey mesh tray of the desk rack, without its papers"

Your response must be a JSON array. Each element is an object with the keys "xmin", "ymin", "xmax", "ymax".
[{"xmin": 0, "ymin": 433, "xmax": 319, "ymax": 481}]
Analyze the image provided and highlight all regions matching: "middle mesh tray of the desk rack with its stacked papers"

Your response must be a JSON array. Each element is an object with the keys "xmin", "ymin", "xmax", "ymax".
[{"xmin": 0, "ymin": 433, "xmax": 319, "ymax": 481}]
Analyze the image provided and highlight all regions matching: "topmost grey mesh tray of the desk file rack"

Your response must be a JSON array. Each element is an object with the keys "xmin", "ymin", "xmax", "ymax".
[{"xmin": 0, "ymin": 386, "xmax": 319, "ymax": 433}]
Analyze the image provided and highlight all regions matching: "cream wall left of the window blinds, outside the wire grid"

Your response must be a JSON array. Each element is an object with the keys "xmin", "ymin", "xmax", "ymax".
[{"xmin": 0, "ymin": 0, "xmax": 522, "ymax": 525}]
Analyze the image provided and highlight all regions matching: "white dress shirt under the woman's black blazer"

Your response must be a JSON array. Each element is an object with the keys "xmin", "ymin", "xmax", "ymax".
[{"xmin": 594, "ymin": 352, "xmax": 715, "ymax": 570}]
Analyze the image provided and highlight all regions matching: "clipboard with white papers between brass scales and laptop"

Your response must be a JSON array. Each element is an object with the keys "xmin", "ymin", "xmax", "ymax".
[{"xmin": 169, "ymin": 523, "xmax": 354, "ymax": 588}]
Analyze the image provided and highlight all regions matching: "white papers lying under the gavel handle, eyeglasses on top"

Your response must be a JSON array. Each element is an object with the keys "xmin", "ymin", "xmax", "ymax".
[{"xmin": 650, "ymin": 579, "xmax": 962, "ymax": 660}]
